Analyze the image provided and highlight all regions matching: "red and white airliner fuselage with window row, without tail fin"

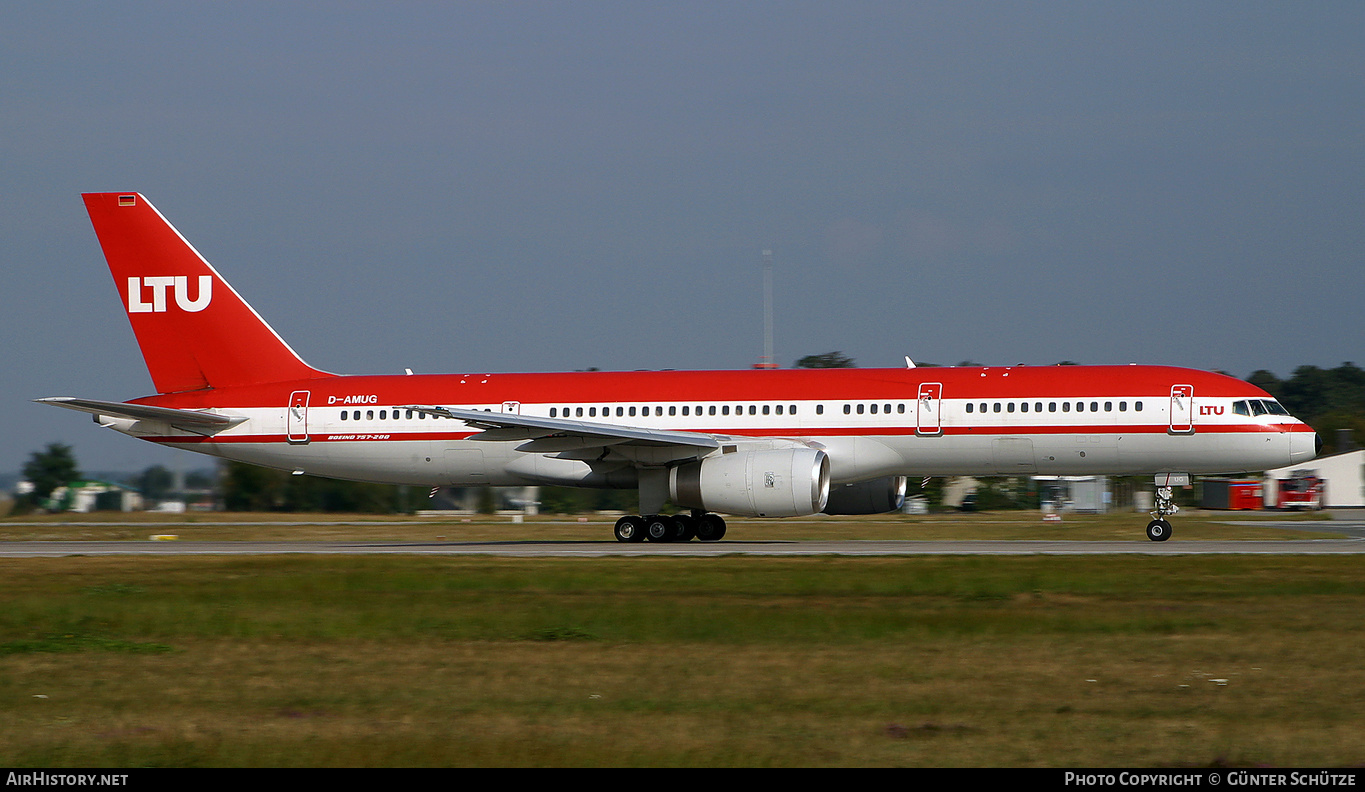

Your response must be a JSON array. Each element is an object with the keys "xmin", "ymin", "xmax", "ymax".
[{"xmin": 113, "ymin": 366, "xmax": 1316, "ymax": 486}]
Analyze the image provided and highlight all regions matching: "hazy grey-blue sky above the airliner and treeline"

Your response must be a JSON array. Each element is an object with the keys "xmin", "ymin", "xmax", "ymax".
[{"xmin": 0, "ymin": 0, "xmax": 1365, "ymax": 470}]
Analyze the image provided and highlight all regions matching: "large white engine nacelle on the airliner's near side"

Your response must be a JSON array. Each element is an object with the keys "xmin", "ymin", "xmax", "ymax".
[{"xmin": 669, "ymin": 448, "xmax": 830, "ymax": 518}]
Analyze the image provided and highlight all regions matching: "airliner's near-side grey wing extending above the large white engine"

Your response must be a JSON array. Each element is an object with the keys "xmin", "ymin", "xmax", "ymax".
[{"xmin": 403, "ymin": 406, "xmax": 721, "ymax": 451}]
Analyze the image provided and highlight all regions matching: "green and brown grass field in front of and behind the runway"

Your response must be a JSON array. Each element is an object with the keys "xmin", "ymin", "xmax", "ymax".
[{"xmin": 0, "ymin": 515, "xmax": 1365, "ymax": 767}]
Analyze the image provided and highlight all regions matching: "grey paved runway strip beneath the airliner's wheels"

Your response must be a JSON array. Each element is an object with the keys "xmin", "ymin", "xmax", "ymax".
[{"xmin": 0, "ymin": 538, "xmax": 1365, "ymax": 558}]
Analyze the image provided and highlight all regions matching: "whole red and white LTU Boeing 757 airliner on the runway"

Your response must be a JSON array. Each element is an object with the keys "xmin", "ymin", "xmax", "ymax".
[{"xmin": 38, "ymin": 193, "xmax": 1320, "ymax": 542}]
